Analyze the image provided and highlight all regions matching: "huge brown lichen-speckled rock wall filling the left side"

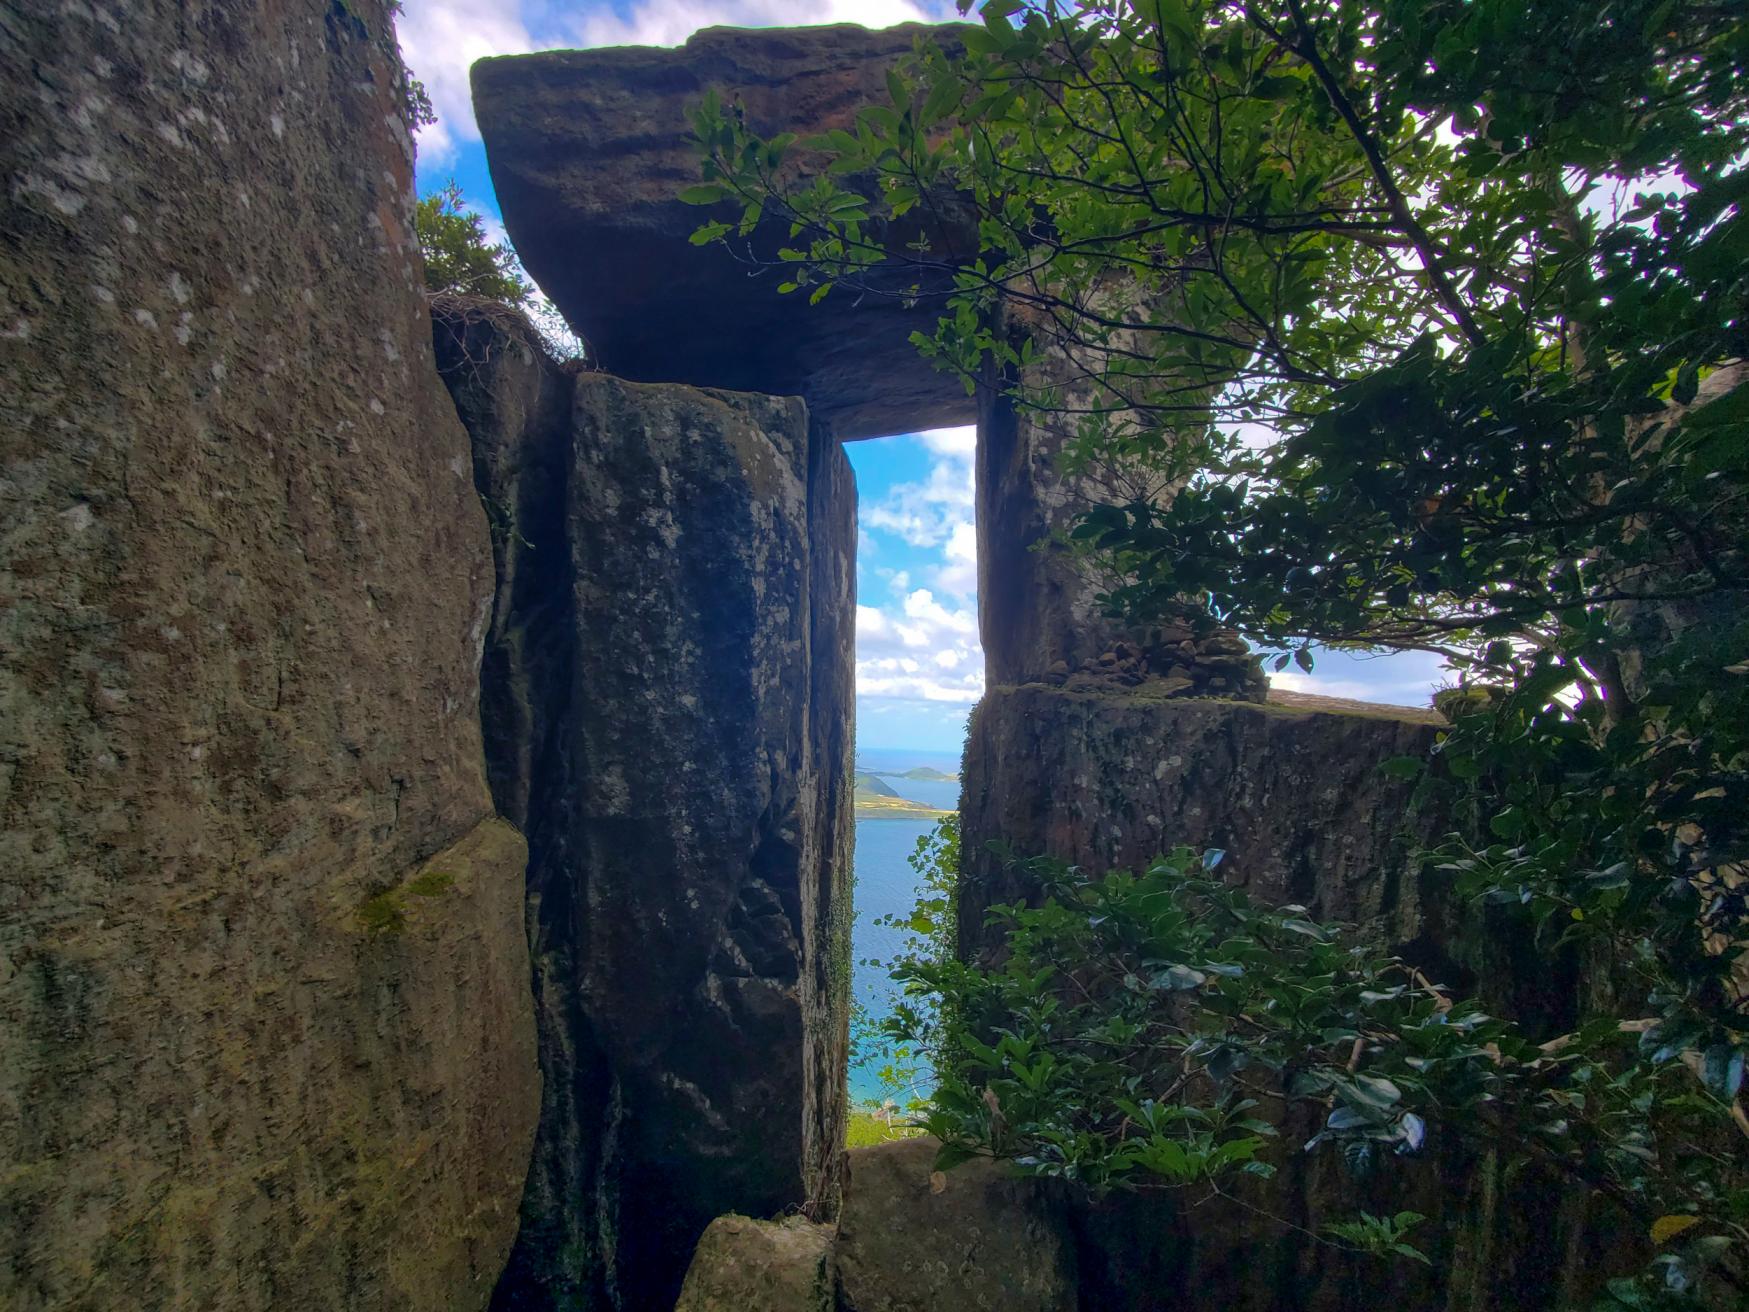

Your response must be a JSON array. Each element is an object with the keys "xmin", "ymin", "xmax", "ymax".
[{"xmin": 0, "ymin": 0, "xmax": 537, "ymax": 1312}]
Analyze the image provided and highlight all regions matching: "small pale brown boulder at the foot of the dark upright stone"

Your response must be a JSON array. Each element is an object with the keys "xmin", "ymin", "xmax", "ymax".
[{"xmin": 673, "ymin": 1216, "xmax": 836, "ymax": 1312}]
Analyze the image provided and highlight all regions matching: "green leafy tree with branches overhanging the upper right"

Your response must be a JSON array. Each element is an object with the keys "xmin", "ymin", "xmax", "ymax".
[{"xmin": 687, "ymin": 0, "xmax": 1749, "ymax": 1305}]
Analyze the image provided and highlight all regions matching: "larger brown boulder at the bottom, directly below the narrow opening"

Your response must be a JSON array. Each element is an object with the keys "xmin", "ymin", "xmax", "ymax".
[{"xmin": 834, "ymin": 1139, "xmax": 1077, "ymax": 1312}]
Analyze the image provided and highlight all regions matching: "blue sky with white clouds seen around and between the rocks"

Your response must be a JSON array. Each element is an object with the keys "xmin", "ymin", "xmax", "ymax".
[{"xmin": 399, "ymin": 0, "xmax": 1443, "ymax": 754}]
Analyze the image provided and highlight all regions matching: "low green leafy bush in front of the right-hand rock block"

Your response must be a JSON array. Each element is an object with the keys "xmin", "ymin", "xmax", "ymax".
[{"xmin": 890, "ymin": 848, "xmax": 1749, "ymax": 1294}]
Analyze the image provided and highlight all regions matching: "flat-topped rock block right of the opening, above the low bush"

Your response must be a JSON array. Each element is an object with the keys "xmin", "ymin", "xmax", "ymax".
[{"xmin": 958, "ymin": 684, "xmax": 1438, "ymax": 952}]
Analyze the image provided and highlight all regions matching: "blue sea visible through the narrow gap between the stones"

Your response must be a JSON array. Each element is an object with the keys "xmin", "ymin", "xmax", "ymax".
[{"xmin": 850, "ymin": 747, "xmax": 960, "ymax": 1104}]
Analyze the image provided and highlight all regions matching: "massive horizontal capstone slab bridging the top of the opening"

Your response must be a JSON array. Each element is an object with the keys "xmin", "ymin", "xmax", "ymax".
[{"xmin": 474, "ymin": 24, "xmax": 976, "ymax": 439}]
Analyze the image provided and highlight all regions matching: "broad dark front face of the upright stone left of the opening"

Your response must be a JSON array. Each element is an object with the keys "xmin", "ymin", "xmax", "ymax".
[{"xmin": 566, "ymin": 376, "xmax": 825, "ymax": 1307}]
